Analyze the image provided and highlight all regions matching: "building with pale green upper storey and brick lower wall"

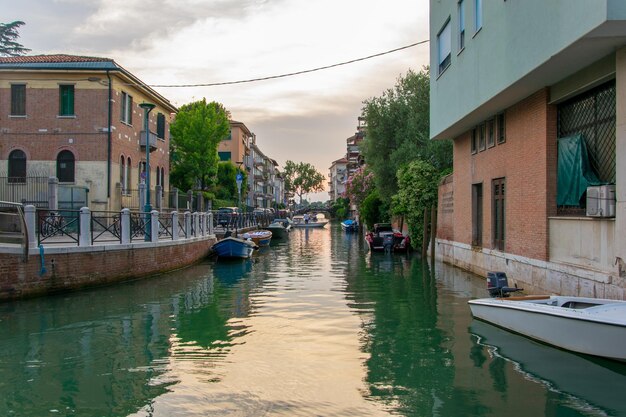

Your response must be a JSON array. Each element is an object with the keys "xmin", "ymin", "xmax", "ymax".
[{"xmin": 430, "ymin": 0, "xmax": 626, "ymax": 299}]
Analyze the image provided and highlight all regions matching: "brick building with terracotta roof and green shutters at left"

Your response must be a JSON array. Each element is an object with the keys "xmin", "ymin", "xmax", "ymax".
[{"xmin": 0, "ymin": 55, "xmax": 176, "ymax": 210}]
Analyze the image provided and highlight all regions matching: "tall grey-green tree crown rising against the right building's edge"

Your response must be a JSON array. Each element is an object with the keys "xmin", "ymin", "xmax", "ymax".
[{"xmin": 360, "ymin": 68, "xmax": 452, "ymax": 201}]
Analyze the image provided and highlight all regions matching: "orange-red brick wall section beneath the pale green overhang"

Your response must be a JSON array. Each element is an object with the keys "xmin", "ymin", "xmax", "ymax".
[{"xmin": 448, "ymin": 89, "xmax": 556, "ymax": 260}]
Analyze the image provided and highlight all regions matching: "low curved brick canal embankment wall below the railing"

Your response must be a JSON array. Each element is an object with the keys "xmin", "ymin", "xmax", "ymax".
[{"xmin": 0, "ymin": 239, "xmax": 215, "ymax": 300}]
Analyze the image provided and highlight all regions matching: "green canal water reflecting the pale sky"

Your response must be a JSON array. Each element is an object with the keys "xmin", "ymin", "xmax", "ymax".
[{"xmin": 0, "ymin": 224, "xmax": 626, "ymax": 416}]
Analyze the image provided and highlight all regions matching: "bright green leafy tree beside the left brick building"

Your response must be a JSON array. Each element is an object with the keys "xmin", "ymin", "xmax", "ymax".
[{"xmin": 170, "ymin": 98, "xmax": 230, "ymax": 191}]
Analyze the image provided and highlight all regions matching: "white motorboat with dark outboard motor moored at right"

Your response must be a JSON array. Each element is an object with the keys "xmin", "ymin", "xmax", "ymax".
[{"xmin": 468, "ymin": 272, "xmax": 626, "ymax": 361}]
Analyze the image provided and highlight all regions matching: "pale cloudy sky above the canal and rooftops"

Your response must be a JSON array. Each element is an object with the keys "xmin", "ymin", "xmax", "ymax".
[{"xmin": 6, "ymin": 0, "xmax": 429, "ymax": 201}]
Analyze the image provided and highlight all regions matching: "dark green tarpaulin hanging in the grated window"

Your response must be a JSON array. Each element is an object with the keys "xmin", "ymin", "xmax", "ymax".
[{"xmin": 556, "ymin": 134, "xmax": 603, "ymax": 206}]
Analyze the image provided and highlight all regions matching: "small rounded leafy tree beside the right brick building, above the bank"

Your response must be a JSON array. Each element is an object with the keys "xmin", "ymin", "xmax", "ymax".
[{"xmin": 392, "ymin": 160, "xmax": 442, "ymax": 247}]
